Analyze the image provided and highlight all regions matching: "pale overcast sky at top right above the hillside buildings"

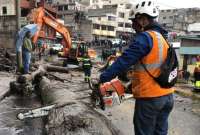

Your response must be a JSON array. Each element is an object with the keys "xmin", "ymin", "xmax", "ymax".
[{"xmin": 130, "ymin": 0, "xmax": 200, "ymax": 9}]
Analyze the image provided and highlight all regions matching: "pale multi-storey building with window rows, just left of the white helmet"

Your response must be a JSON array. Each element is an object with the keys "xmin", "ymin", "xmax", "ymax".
[{"xmin": 88, "ymin": 3, "xmax": 133, "ymax": 40}]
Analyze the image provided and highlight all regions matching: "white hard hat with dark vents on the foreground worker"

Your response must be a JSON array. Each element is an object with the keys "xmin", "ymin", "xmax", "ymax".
[{"xmin": 129, "ymin": 0, "xmax": 159, "ymax": 19}]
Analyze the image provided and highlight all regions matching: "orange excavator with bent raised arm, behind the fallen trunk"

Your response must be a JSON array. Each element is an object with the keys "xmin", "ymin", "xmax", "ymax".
[{"xmin": 31, "ymin": 7, "xmax": 96, "ymax": 61}]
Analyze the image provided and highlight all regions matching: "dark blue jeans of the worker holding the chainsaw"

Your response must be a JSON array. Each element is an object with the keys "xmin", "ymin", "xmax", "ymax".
[{"xmin": 133, "ymin": 94, "xmax": 174, "ymax": 135}]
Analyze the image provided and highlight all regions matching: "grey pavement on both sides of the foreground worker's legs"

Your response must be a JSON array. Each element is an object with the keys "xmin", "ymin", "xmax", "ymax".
[{"xmin": 102, "ymin": 95, "xmax": 200, "ymax": 135}]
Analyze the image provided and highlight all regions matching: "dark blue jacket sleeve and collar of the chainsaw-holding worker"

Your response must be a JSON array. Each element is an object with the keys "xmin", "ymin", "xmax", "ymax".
[{"xmin": 100, "ymin": 23, "xmax": 167, "ymax": 83}]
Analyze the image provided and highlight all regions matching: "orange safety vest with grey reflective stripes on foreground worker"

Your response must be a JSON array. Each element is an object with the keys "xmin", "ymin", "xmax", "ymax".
[{"xmin": 131, "ymin": 31, "xmax": 174, "ymax": 98}]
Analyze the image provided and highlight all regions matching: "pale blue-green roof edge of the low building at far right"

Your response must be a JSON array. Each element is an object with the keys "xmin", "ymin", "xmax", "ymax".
[{"xmin": 180, "ymin": 47, "xmax": 200, "ymax": 55}]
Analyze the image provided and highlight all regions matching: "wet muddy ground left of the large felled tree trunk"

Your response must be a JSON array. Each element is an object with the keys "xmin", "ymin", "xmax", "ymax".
[{"xmin": 0, "ymin": 72, "xmax": 44, "ymax": 135}]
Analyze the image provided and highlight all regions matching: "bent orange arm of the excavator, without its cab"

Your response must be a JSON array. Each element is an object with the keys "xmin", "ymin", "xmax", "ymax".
[{"xmin": 33, "ymin": 7, "xmax": 71, "ymax": 53}]
